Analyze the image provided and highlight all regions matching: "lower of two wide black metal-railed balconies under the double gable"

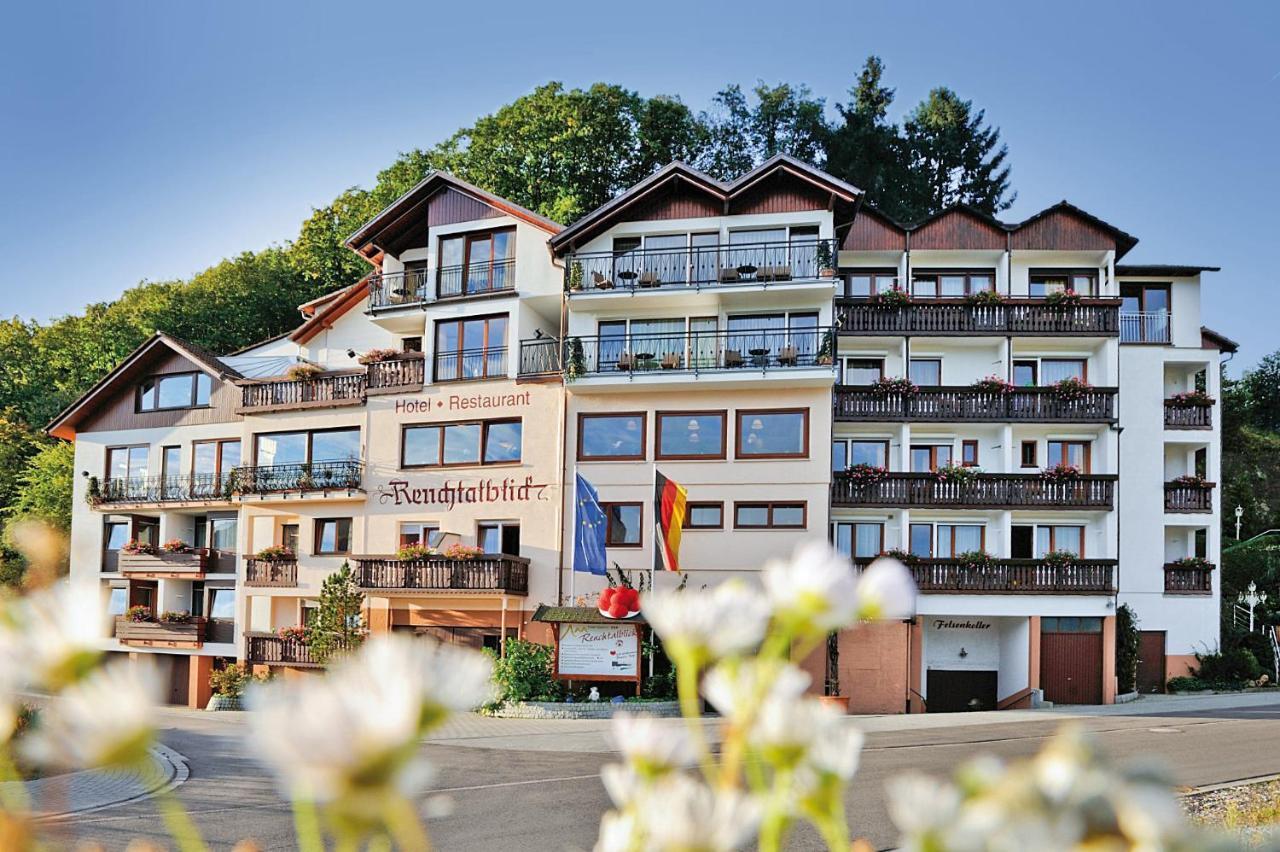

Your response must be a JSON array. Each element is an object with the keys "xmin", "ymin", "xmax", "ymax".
[{"xmin": 520, "ymin": 329, "xmax": 833, "ymax": 379}]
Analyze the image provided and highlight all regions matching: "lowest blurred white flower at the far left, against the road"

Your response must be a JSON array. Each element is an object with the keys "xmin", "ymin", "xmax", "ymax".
[{"xmin": 22, "ymin": 659, "xmax": 161, "ymax": 769}]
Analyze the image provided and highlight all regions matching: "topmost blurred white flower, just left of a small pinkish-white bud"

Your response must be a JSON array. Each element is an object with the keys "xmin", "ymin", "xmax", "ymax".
[{"xmin": 762, "ymin": 542, "xmax": 858, "ymax": 632}]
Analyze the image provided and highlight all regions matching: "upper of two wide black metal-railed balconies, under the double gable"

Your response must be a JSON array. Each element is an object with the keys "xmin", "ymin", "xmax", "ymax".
[{"xmin": 564, "ymin": 239, "xmax": 835, "ymax": 291}]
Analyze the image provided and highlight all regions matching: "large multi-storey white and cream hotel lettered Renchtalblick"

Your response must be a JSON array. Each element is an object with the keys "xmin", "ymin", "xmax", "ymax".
[{"xmin": 50, "ymin": 156, "xmax": 1234, "ymax": 713}]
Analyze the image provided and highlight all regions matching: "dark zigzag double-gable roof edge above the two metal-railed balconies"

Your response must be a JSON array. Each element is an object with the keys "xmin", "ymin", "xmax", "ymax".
[{"xmin": 548, "ymin": 154, "xmax": 863, "ymax": 252}]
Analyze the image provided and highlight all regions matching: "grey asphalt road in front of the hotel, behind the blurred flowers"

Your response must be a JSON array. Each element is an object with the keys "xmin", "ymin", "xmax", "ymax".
[{"xmin": 45, "ymin": 702, "xmax": 1280, "ymax": 852}]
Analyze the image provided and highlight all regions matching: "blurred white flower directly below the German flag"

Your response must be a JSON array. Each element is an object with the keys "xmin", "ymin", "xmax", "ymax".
[{"xmin": 641, "ymin": 580, "xmax": 769, "ymax": 663}]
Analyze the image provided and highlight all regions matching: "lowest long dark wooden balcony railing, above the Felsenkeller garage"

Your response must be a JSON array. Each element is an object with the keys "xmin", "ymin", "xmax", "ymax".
[{"xmin": 855, "ymin": 559, "xmax": 1117, "ymax": 595}]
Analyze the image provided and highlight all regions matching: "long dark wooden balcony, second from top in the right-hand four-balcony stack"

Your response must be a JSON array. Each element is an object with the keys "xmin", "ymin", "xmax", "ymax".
[{"xmin": 835, "ymin": 385, "xmax": 1116, "ymax": 423}]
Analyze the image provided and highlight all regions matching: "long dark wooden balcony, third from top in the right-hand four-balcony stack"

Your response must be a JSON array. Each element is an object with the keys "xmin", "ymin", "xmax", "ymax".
[{"xmin": 831, "ymin": 471, "xmax": 1117, "ymax": 510}]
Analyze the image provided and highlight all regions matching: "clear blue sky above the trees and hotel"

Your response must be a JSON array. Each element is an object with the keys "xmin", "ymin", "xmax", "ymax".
[{"xmin": 0, "ymin": 0, "xmax": 1280, "ymax": 365}]
